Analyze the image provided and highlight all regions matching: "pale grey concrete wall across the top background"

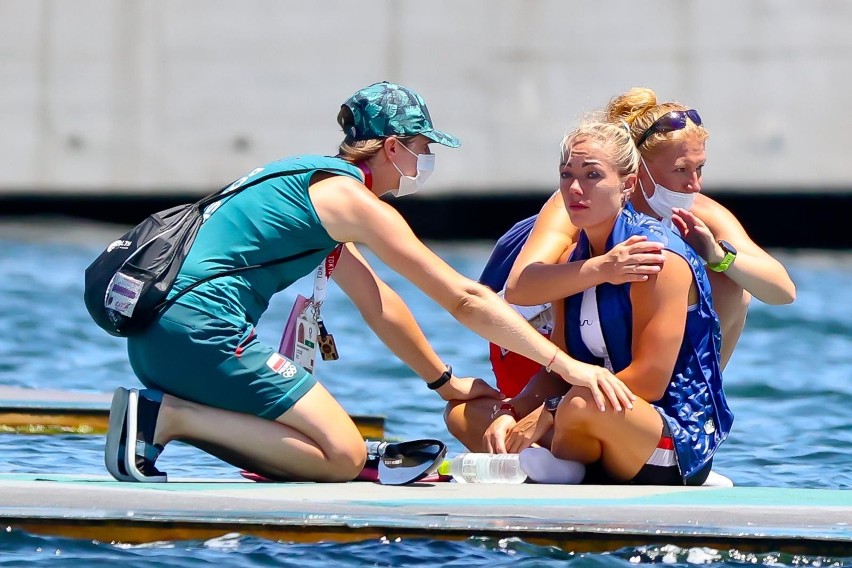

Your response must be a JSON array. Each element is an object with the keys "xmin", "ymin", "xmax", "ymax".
[{"xmin": 0, "ymin": 0, "xmax": 852, "ymax": 194}]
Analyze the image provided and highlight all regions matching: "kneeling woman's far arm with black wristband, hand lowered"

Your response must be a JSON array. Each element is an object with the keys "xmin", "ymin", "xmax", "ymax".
[{"xmin": 332, "ymin": 243, "xmax": 500, "ymax": 400}]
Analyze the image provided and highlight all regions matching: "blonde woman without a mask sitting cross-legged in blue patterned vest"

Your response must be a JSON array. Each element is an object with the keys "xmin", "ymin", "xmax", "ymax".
[{"xmin": 445, "ymin": 120, "xmax": 733, "ymax": 485}]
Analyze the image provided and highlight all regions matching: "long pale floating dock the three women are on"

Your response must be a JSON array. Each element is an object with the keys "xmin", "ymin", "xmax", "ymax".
[{"xmin": 0, "ymin": 473, "xmax": 852, "ymax": 556}]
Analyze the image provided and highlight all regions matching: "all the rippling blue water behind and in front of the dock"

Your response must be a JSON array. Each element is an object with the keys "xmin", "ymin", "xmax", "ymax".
[{"xmin": 0, "ymin": 219, "xmax": 852, "ymax": 567}]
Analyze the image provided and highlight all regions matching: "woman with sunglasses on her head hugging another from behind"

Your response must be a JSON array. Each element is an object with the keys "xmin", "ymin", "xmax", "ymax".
[{"xmin": 484, "ymin": 87, "xmax": 796, "ymax": 390}]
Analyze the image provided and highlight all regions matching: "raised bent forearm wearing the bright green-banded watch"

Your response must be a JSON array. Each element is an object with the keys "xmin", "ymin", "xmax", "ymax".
[{"xmin": 672, "ymin": 195, "xmax": 796, "ymax": 305}]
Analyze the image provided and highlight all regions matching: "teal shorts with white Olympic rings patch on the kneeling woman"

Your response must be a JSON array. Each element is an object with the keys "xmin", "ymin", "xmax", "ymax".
[{"xmin": 127, "ymin": 304, "xmax": 316, "ymax": 420}]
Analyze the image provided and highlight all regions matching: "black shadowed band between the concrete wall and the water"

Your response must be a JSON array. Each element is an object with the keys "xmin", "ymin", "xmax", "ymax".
[{"xmin": 0, "ymin": 192, "xmax": 852, "ymax": 249}]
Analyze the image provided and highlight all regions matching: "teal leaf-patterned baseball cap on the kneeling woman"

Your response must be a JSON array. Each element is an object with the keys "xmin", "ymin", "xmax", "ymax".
[{"xmin": 343, "ymin": 81, "xmax": 461, "ymax": 148}]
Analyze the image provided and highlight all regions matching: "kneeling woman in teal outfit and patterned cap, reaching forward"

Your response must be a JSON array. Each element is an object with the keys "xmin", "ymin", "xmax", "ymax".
[{"xmin": 105, "ymin": 82, "xmax": 634, "ymax": 481}]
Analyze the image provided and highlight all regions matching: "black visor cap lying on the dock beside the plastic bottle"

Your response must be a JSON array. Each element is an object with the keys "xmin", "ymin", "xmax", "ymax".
[{"xmin": 379, "ymin": 439, "xmax": 447, "ymax": 485}]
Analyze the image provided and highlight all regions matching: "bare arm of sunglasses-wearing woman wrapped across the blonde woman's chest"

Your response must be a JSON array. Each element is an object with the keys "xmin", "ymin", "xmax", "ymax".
[{"xmin": 505, "ymin": 191, "xmax": 663, "ymax": 306}]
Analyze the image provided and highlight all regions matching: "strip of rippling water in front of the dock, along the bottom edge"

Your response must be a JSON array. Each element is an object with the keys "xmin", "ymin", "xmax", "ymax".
[{"xmin": 0, "ymin": 530, "xmax": 852, "ymax": 568}]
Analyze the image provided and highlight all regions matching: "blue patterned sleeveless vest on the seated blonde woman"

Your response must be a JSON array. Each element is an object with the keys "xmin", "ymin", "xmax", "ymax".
[{"xmin": 565, "ymin": 204, "xmax": 734, "ymax": 481}]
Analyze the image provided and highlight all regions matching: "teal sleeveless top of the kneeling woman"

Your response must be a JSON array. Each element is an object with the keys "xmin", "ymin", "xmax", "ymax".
[{"xmin": 169, "ymin": 156, "xmax": 361, "ymax": 326}]
